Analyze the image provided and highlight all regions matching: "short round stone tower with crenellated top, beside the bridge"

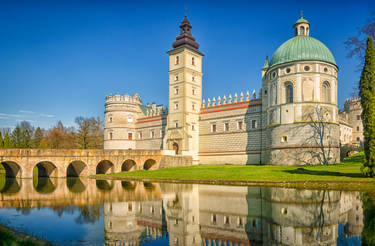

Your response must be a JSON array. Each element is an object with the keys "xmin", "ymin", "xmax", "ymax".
[{"xmin": 104, "ymin": 94, "xmax": 142, "ymax": 149}]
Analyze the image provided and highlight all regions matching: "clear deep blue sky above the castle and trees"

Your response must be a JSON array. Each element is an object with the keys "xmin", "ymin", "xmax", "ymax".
[{"xmin": 0, "ymin": 0, "xmax": 375, "ymax": 128}]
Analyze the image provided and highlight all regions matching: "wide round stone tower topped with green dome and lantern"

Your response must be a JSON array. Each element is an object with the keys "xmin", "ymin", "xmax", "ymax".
[{"xmin": 262, "ymin": 17, "xmax": 340, "ymax": 165}]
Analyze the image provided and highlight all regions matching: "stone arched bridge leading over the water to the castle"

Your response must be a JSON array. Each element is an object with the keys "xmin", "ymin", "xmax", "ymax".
[{"xmin": 0, "ymin": 149, "xmax": 192, "ymax": 178}]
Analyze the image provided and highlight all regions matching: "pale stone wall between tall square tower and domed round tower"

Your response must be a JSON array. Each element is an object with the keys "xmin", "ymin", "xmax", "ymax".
[{"xmin": 199, "ymin": 99, "xmax": 262, "ymax": 164}]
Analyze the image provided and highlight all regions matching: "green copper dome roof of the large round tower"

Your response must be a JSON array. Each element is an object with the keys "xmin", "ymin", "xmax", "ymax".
[{"xmin": 269, "ymin": 36, "xmax": 336, "ymax": 67}]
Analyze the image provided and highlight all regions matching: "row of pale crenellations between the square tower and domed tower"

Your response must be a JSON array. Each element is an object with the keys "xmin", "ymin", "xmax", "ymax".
[{"xmin": 202, "ymin": 90, "xmax": 257, "ymax": 108}]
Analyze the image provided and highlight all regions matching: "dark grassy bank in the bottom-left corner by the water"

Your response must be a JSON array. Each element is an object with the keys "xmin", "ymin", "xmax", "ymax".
[{"xmin": 0, "ymin": 226, "xmax": 52, "ymax": 246}]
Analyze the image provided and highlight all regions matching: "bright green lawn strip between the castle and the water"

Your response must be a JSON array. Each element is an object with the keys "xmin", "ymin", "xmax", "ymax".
[{"xmin": 100, "ymin": 153, "xmax": 375, "ymax": 188}]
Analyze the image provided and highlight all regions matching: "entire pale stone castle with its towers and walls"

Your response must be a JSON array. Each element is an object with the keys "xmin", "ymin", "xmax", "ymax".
[{"xmin": 104, "ymin": 13, "xmax": 362, "ymax": 165}]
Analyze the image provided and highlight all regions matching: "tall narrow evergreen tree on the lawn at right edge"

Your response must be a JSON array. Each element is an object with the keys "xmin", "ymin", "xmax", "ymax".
[{"xmin": 359, "ymin": 37, "xmax": 375, "ymax": 177}]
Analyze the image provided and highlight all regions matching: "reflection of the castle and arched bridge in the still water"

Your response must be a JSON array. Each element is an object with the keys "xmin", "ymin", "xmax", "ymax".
[{"xmin": 0, "ymin": 178, "xmax": 364, "ymax": 246}]
